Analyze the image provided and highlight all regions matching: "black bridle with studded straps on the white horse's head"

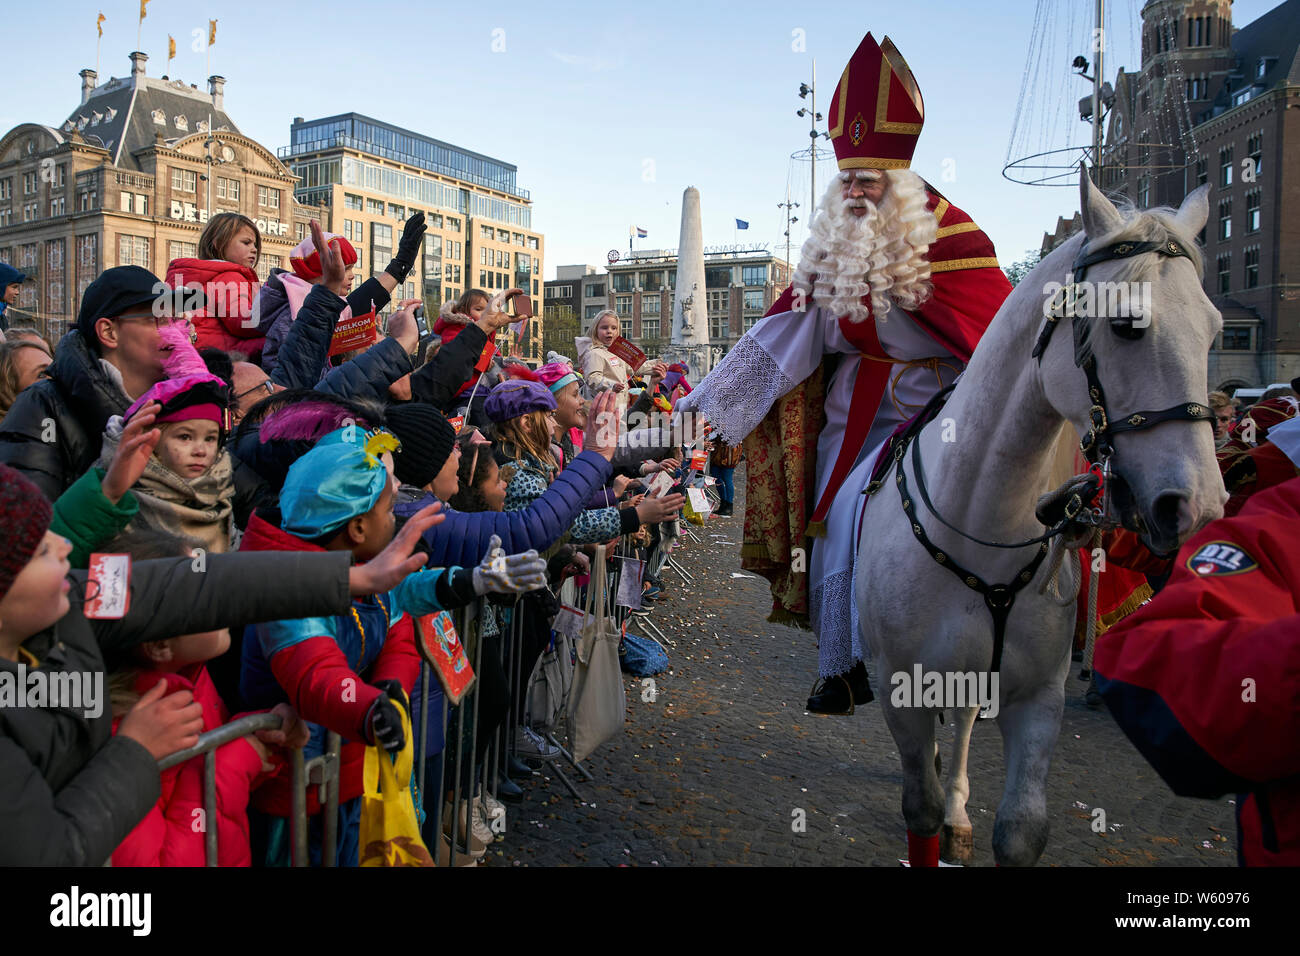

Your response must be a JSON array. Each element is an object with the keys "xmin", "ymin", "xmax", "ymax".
[{"xmin": 1032, "ymin": 235, "xmax": 1214, "ymax": 463}]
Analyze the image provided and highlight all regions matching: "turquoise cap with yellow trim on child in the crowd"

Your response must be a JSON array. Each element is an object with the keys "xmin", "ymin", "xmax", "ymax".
[{"xmin": 280, "ymin": 425, "xmax": 400, "ymax": 541}]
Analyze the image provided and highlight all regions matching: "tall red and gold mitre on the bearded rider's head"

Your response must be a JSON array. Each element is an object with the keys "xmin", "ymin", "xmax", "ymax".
[{"xmin": 828, "ymin": 34, "xmax": 926, "ymax": 169}]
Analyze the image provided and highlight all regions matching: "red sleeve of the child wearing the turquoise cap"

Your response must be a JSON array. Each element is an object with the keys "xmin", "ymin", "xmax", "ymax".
[{"xmin": 270, "ymin": 636, "xmax": 382, "ymax": 740}]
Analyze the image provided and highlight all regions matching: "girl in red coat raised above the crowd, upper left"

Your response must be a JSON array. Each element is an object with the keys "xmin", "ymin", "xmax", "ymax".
[{"xmin": 165, "ymin": 212, "xmax": 267, "ymax": 358}]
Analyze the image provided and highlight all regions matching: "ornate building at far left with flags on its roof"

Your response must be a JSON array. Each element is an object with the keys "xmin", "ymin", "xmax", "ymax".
[{"xmin": 0, "ymin": 52, "xmax": 319, "ymax": 338}]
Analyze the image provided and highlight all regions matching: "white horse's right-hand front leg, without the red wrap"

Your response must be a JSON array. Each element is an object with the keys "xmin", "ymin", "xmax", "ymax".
[{"xmin": 993, "ymin": 680, "xmax": 1065, "ymax": 866}]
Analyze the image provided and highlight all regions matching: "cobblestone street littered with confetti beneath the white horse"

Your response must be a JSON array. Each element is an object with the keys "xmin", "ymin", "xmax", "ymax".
[{"xmin": 489, "ymin": 473, "xmax": 1235, "ymax": 866}]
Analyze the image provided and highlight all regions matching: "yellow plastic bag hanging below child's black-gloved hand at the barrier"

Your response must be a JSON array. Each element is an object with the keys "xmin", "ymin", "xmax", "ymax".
[{"xmin": 360, "ymin": 704, "xmax": 433, "ymax": 866}]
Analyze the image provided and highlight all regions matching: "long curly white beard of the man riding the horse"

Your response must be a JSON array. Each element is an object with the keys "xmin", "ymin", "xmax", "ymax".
[{"xmin": 792, "ymin": 169, "xmax": 939, "ymax": 323}]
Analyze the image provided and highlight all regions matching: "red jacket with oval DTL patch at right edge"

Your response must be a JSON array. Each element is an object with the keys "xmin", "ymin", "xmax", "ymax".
[{"xmin": 1093, "ymin": 479, "xmax": 1300, "ymax": 866}]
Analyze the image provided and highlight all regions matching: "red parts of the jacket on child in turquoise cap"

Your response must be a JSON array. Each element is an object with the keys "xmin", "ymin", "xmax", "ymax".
[{"xmin": 239, "ymin": 512, "xmax": 420, "ymax": 817}]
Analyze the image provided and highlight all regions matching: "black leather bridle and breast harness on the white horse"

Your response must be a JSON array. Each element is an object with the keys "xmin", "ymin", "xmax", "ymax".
[{"xmin": 889, "ymin": 237, "xmax": 1214, "ymax": 674}]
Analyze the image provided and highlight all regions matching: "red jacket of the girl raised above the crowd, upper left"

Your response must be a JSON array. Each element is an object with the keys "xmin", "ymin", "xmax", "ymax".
[{"xmin": 166, "ymin": 259, "xmax": 267, "ymax": 355}]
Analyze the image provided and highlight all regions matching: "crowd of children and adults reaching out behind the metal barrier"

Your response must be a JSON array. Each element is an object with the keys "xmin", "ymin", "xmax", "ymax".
[{"xmin": 0, "ymin": 213, "xmax": 712, "ymax": 866}]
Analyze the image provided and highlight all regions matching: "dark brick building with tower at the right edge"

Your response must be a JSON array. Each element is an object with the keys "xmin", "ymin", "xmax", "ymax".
[{"xmin": 1102, "ymin": 0, "xmax": 1300, "ymax": 390}]
